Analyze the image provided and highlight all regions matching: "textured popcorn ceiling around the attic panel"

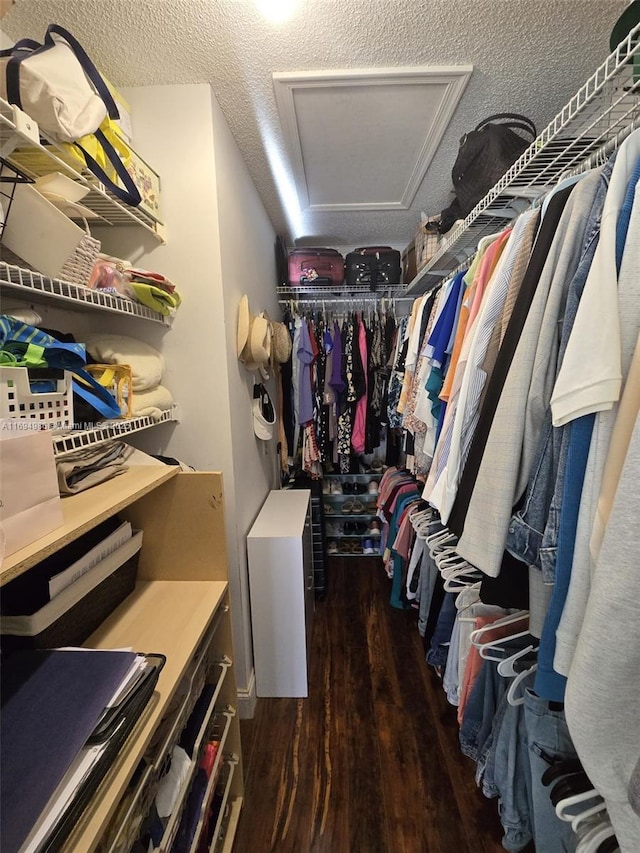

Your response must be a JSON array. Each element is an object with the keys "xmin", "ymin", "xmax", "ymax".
[{"xmin": 2, "ymin": 0, "xmax": 627, "ymax": 247}]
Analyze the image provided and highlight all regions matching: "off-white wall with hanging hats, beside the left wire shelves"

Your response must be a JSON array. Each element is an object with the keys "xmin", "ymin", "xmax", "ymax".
[{"xmin": 98, "ymin": 84, "xmax": 278, "ymax": 716}]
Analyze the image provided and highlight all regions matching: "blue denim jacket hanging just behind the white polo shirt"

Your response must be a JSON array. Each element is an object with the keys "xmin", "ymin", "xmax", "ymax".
[{"xmin": 506, "ymin": 158, "xmax": 613, "ymax": 583}]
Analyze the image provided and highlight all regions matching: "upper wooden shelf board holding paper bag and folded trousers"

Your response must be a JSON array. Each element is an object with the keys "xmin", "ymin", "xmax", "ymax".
[{"xmin": 0, "ymin": 465, "xmax": 179, "ymax": 586}]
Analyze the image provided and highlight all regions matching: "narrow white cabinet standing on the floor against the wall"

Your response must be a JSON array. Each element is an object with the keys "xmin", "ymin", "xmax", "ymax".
[{"xmin": 247, "ymin": 489, "xmax": 314, "ymax": 696}]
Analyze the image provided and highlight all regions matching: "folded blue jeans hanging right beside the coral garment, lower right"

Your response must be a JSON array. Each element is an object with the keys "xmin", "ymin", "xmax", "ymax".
[{"xmin": 459, "ymin": 650, "xmax": 510, "ymax": 761}]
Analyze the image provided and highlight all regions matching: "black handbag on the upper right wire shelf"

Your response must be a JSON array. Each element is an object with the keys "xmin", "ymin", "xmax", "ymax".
[{"xmin": 440, "ymin": 113, "xmax": 538, "ymax": 233}]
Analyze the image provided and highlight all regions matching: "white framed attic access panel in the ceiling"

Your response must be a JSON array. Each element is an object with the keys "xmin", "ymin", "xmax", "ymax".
[{"xmin": 273, "ymin": 65, "xmax": 473, "ymax": 211}]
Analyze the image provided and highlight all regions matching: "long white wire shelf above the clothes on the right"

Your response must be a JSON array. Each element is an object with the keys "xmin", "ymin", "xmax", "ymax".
[{"xmin": 405, "ymin": 25, "xmax": 640, "ymax": 295}]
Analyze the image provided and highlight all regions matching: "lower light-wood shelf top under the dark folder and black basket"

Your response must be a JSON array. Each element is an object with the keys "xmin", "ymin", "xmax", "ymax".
[{"xmin": 65, "ymin": 581, "xmax": 227, "ymax": 851}]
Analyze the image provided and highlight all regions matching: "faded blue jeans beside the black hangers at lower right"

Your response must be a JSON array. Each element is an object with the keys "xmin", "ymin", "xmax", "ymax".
[{"xmin": 524, "ymin": 690, "xmax": 577, "ymax": 853}]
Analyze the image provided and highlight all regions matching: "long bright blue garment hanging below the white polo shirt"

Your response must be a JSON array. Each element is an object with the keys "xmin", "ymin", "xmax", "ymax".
[{"xmin": 534, "ymin": 414, "xmax": 595, "ymax": 702}]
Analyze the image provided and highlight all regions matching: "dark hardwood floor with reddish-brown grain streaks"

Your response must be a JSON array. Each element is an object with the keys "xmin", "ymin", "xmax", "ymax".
[{"xmin": 234, "ymin": 558, "xmax": 516, "ymax": 853}]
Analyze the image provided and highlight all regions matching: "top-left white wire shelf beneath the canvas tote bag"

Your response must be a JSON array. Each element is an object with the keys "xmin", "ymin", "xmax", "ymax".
[{"xmin": 0, "ymin": 98, "xmax": 167, "ymax": 243}]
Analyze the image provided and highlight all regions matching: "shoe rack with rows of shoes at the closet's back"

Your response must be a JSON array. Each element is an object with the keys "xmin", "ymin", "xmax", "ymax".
[{"xmin": 322, "ymin": 472, "xmax": 382, "ymax": 557}]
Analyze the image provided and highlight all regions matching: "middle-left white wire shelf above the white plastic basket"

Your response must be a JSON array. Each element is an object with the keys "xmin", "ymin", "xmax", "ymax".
[{"xmin": 0, "ymin": 260, "xmax": 172, "ymax": 326}]
